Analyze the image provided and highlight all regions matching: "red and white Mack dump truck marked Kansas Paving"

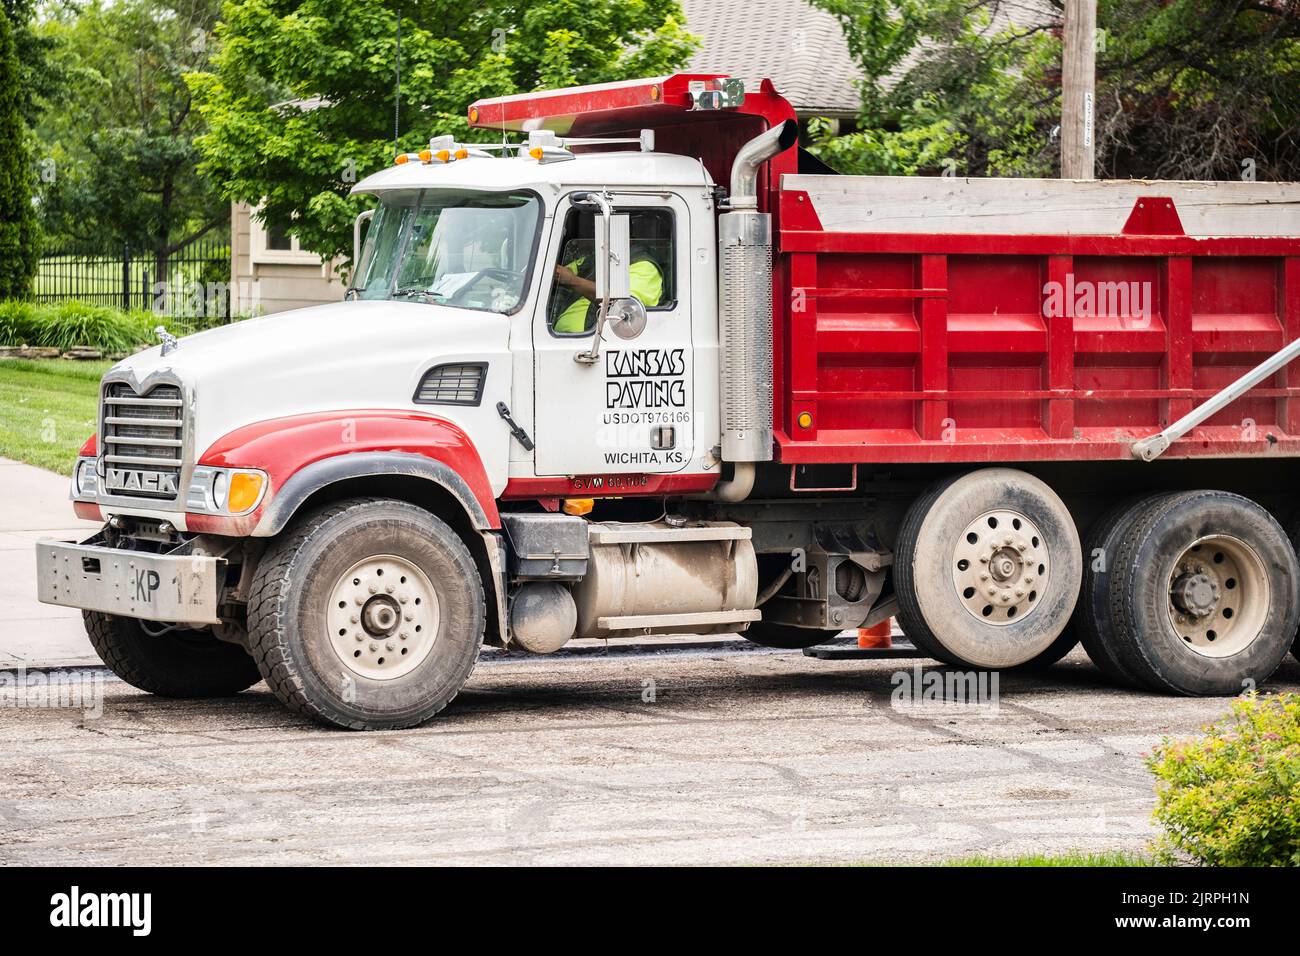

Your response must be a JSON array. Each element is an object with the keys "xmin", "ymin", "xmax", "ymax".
[{"xmin": 38, "ymin": 74, "xmax": 1300, "ymax": 728}]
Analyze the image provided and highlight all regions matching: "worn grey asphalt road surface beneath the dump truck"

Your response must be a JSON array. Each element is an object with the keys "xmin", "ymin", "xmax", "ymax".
[{"xmin": 0, "ymin": 648, "xmax": 1300, "ymax": 865}]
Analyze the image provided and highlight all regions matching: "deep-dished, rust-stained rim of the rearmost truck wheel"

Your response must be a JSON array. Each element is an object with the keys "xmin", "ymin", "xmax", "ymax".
[{"xmin": 1169, "ymin": 535, "xmax": 1269, "ymax": 657}]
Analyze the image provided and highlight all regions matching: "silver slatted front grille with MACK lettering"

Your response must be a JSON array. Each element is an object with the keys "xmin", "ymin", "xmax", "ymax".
[{"xmin": 101, "ymin": 381, "xmax": 185, "ymax": 499}]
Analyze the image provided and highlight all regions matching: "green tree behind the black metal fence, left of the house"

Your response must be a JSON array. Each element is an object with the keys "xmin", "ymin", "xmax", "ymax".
[{"xmin": 38, "ymin": 0, "xmax": 229, "ymax": 278}]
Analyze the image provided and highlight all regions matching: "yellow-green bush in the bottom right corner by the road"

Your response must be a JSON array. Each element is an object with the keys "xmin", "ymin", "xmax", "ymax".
[{"xmin": 1147, "ymin": 695, "xmax": 1300, "ymax": 866}]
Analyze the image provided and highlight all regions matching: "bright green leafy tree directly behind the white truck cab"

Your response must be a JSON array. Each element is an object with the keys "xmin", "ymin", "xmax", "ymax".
[{"xmin": 190, "ymin": 0, "xmax": 694, "ymax": 269}]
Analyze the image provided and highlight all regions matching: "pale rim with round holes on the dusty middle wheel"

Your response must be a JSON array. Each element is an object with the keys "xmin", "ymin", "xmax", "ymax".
[{"xmin": 953, "ymin": 509, "xmax": 1052, "ymax": 627}]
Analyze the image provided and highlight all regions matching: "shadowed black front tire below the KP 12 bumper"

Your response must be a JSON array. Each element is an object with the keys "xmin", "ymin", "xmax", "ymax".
[{"xmin": 82, "ymin": 611, "xmax": 261, "ymax": 698}]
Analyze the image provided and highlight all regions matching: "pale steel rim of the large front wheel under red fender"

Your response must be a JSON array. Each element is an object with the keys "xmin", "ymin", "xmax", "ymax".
[{"xmin": 325, "ymin": 554, "xmax": 441, "ymax": 680}]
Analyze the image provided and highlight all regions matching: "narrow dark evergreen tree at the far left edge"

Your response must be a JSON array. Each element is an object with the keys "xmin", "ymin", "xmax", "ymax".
[{"xmin": 0, "ymin": 8, "xmax": 39, "ymax": 299}]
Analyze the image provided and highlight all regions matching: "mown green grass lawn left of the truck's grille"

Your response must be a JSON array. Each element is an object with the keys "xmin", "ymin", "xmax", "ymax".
[{"xmin": 0, "ymin": 359, "xmax": 113, "ymax": 475}]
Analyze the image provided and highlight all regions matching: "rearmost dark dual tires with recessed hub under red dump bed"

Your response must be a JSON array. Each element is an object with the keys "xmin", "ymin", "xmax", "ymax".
[{"xmin": 1108, "ymin": 490, "xmax": 1300, "ymax": 696}]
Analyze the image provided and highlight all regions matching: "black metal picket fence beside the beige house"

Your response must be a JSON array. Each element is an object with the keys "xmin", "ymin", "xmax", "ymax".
[{"xmin": 33, "ymin": 237, "xmax": 231, "ymax": 328}]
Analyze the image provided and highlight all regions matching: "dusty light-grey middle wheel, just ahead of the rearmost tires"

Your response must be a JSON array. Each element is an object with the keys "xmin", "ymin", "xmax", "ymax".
[{"xmin": 894, "ymin": 468, "xmax": 1083, "ymax": 669}]
